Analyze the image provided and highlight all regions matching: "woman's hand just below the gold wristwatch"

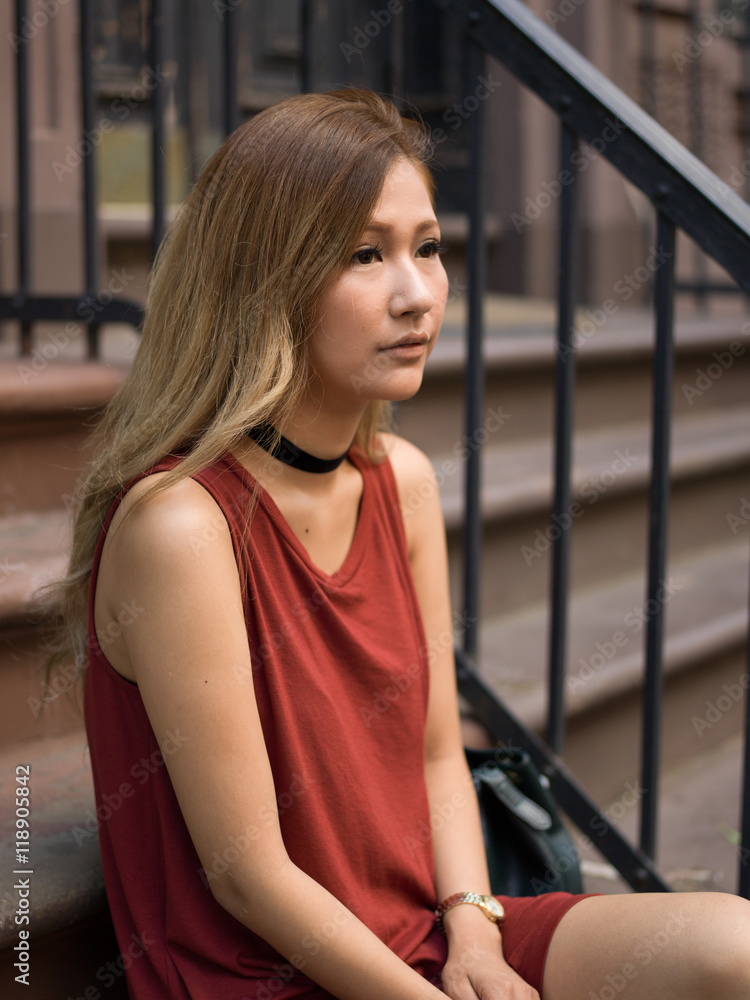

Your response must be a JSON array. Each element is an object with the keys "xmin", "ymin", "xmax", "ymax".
[{"xmin": 442, "ymin": 941, "xmax": 539, "ymax": 1000}]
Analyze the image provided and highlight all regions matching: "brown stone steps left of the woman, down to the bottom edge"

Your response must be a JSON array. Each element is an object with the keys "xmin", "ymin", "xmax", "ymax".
[{"xmin": 0, "ymin": 358, "xmax": 127, "ymax": 1000}]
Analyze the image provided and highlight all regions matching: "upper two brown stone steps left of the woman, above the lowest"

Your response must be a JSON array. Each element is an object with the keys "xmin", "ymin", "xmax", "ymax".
[{"xmin": 0, "ymin": 355, "xmax": 126, "ymax": 746}]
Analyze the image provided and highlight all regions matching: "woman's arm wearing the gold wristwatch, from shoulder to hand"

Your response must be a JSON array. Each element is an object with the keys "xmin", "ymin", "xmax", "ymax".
[{"xmin": 390, "ymin": 438, "xmax": 538, "ymax": 1000}]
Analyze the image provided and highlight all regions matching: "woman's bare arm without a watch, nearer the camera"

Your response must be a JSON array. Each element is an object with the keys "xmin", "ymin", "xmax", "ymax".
[{"xmin": 97, "ymin": 480, "xmax": 442, "ymax": 1000}]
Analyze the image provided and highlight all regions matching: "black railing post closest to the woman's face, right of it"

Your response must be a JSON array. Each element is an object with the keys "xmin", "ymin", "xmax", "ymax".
[{"xmin": 463, "ymin": 40, "xmax": 485, "ymax": 659}]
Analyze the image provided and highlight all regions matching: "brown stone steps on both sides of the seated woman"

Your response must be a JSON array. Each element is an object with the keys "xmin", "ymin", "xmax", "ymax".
[{"xmin": 0, "ymin": 298, "xmax": 750, "ymax": 1000}]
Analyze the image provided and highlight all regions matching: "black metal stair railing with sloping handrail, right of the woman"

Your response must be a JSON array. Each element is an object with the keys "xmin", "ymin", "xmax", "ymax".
[{"xmin": 434, "ymin": 0, "xmax": 750, "ymax": 897}]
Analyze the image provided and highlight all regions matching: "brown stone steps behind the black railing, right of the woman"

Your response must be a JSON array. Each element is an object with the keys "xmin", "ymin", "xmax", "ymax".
[{"xmin": 408, "ymin": 309, "xmax": 750, "ymax": 892}]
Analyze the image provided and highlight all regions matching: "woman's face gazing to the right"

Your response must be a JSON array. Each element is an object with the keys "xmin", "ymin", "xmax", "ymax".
[{"xmin": 308, "ymin": 159, "xmax": 448, "ymax": 410}]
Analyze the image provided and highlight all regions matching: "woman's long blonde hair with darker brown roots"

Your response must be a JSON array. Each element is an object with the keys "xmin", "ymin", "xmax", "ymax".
[{"xmin": 46, "ymin": 89, "xmax": 432, "ymax": 671}]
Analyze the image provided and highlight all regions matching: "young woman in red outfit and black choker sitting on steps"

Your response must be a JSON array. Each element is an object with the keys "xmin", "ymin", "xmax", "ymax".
[{"xmin": 55, "ymin": 91, "xmax": 750, "ymax": 1000}]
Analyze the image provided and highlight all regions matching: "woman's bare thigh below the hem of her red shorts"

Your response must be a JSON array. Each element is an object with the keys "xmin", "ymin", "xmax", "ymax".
[{"xmin": 543, "ymin": 892, "xmax": 750, "ymax": 1000}]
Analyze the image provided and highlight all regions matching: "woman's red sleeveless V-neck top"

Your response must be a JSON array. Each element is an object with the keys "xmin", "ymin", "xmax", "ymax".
[{"xmin": 85, "ymin": 452, "xmax": 445, "ymax": 1000}]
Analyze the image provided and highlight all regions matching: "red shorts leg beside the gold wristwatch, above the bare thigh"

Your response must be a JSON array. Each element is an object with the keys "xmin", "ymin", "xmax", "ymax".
[{"xmin": 497, "ymin": 892, "xmax": 597, "ymax": 997}]
